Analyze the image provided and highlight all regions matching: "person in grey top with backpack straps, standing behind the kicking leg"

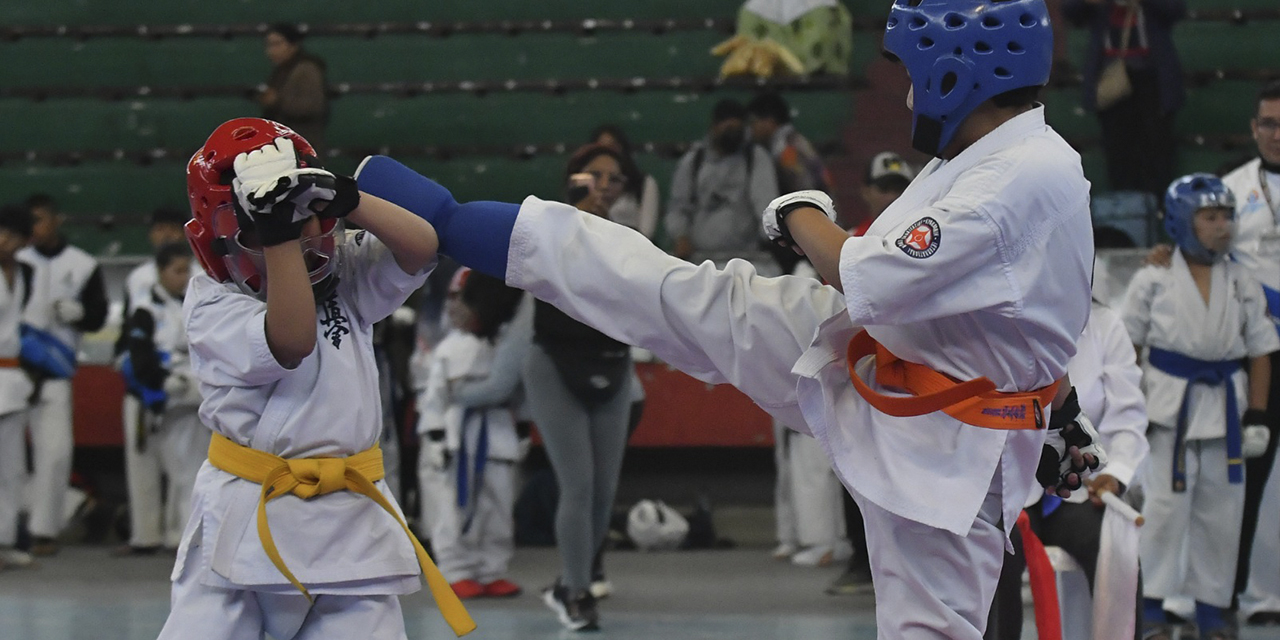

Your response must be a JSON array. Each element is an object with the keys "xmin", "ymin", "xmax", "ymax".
[{"xmin": 666, "ymin": 100, "xmax": 781, "ymax": 275}]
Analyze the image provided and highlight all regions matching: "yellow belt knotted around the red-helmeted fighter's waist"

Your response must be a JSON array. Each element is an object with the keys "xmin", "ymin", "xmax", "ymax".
[{"xmin": 209, "ymin": 433, "xmax": 476, "ymax": 636}]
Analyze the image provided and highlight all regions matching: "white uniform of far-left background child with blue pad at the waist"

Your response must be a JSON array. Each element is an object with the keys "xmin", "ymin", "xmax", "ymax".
[{"xmin": 18, "ymin": 246, "xmax": 99, "ymax": 538}]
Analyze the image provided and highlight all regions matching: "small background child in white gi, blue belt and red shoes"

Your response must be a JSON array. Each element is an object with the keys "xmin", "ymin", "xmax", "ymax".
[{"xmin": 419, "ymin": 269, "xmax": 524, "ymax": 599}]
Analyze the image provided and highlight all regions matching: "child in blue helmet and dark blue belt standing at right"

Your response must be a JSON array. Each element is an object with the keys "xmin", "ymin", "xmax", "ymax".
[{"xmin": 1124, "ymin": 173, "xmax": 1280, "ymax": 640}]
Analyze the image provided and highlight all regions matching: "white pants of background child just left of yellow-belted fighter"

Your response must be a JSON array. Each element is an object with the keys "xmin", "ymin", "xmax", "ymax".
[{"xmin": 124, "ymin": 396, "xmax": 212, "ymax": 548}]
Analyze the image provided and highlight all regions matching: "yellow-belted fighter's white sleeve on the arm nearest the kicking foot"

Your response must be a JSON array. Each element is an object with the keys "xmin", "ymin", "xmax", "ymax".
[{"xmin": 338, "ymin": 230, "xmax": 435, "ymax": 326}]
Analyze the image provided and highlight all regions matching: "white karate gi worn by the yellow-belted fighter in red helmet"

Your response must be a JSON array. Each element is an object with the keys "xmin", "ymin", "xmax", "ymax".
[{"xmin": 160, "ymin": 232, "xmax": 434, "ymax": 640}]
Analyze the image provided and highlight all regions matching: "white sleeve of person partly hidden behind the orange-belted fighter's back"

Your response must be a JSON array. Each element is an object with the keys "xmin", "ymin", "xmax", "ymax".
[{"xmin": 1091, "ymin": 307, "xmax": 1151, "ymax": 486}]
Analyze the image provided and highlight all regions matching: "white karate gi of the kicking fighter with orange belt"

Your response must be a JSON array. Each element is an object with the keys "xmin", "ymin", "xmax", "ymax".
[{"xmin": 507, "ymin": 108, "xmax": 1093, "ymax": 639}]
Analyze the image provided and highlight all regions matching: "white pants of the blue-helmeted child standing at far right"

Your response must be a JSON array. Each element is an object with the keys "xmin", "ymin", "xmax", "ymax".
[{"xmin": 1140, "ymin": 425, "xmax": 1244, "ymax": 607}]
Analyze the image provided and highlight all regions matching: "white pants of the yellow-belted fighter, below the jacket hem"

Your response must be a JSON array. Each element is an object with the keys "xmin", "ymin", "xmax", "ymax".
[{"xmin": 157, "ymin": 544, "xmax": 407, "ymax": 640}]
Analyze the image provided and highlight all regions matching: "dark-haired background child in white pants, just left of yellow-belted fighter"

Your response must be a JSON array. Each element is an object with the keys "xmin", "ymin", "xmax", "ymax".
[{"xmin": 115, "ymin": 242, "xmax": 209, "ymax": 556}]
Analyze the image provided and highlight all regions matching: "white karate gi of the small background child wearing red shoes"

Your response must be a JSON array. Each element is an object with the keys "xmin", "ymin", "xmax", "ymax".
[{"xmin": 419, "ymin": 330, "xmax": 518, "ymax": 584}]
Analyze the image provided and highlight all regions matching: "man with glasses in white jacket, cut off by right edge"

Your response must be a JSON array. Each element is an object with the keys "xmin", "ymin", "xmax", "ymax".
[{"xmin": 1222, "ymin": 81, "xmax": 1280, "ymax": 623}]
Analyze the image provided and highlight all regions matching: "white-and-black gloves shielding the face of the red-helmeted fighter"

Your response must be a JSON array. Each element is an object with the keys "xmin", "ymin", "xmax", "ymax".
[{"xmin": 232, "ymin": 136, "xmax": 337, "ymax": 223}]
